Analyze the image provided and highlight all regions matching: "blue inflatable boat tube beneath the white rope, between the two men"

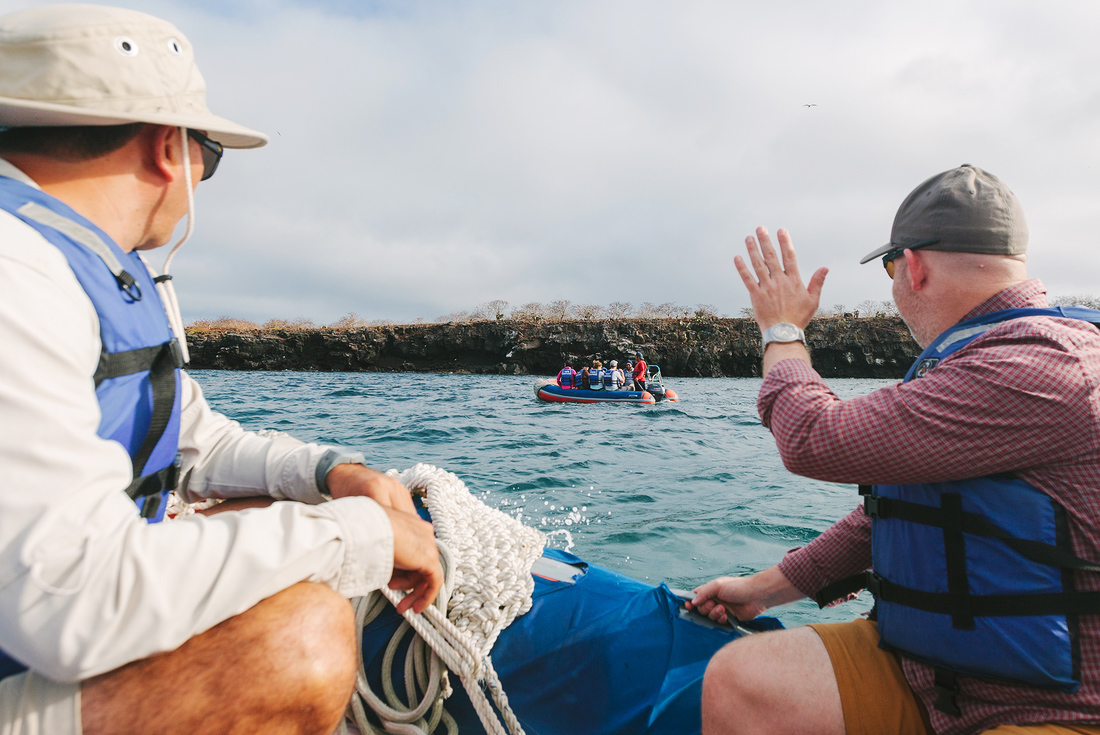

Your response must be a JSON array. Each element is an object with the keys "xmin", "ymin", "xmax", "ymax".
[{"xmin": 363, "ymin": 549, "xmax": 783, "ymax": 735}]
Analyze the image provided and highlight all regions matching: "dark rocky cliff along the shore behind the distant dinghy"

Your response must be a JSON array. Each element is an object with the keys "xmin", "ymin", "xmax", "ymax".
[{"xmin": 188, "ymin": 317, "xmax": 920, "ymax": 377}]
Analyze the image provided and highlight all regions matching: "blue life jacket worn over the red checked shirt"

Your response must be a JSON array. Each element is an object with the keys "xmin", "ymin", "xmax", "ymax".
[{"xmin": 816, "ymin": 307, "xmax": 1100, "ymax": 716}]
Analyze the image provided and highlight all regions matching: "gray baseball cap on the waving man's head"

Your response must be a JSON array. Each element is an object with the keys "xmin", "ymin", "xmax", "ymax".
[{"xmin": 859, "ymin": 164, "xmax": 1027, "ymax": 263}]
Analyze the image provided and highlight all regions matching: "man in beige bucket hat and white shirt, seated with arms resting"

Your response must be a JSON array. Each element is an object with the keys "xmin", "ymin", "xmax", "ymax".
[{"xmin": 0, "ymin": 6, "xmax": 442, "ymax": 735}]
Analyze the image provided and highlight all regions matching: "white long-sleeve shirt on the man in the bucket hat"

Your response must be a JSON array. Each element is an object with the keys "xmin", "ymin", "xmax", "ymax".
[{"xmin": 0, "ymin": 160, "xmax": 393, "ymax": 681}]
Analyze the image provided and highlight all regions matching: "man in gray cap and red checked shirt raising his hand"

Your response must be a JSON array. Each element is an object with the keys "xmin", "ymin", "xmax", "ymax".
[{"xmin": 692, "ymin": 165, "xmax": 1100, "ymax": 735}]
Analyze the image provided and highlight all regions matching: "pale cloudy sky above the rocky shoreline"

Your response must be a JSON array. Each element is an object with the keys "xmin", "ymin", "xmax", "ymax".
[{"xmin": 10, "ymin": 0, "xmax": 1100, "ymax": 323}]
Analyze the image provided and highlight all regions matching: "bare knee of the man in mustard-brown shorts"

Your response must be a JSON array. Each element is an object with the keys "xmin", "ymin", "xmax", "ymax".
[{"xmin": 703, "ymin": 627, "xmax": 845, "ymax": 735}]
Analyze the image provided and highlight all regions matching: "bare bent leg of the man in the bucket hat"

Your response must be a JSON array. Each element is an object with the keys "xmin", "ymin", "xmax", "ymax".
[{"xmin": 81, "ymin": 582, "xmax": 359, "ymax": 735}]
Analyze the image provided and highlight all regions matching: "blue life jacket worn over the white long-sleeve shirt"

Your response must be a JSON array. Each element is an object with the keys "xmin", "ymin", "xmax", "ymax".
[{"xmin": 0, "ymin": 176, "xmax": 183, "ymax": 679}]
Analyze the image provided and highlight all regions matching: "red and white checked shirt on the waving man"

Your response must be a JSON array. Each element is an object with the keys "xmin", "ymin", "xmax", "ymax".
[{"xmin": 770, "ymin": 279, "xmax": 1100, "ymax": 735}]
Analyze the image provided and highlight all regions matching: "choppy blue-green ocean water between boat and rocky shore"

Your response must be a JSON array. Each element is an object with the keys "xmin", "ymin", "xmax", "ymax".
[{"xmin": 191, "ymin": 371, "xmax": 889, "ymax": 626}]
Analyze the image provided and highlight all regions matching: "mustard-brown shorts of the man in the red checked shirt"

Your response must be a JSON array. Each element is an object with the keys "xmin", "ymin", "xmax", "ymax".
[{"xmin": 810, "ymin": 619, "xmax": 1100, "ymax": 735}]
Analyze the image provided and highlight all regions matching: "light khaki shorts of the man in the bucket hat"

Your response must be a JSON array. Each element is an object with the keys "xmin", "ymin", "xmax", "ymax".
[{"xmin": 0, "ymin": 671, "xmax": 80, "ymax": 735}]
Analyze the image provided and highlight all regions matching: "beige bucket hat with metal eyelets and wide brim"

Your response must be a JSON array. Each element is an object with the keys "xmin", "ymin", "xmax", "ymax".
[{"xmin": 0, "ymin": 4, "xmax": 268, "ymax": 149}]
